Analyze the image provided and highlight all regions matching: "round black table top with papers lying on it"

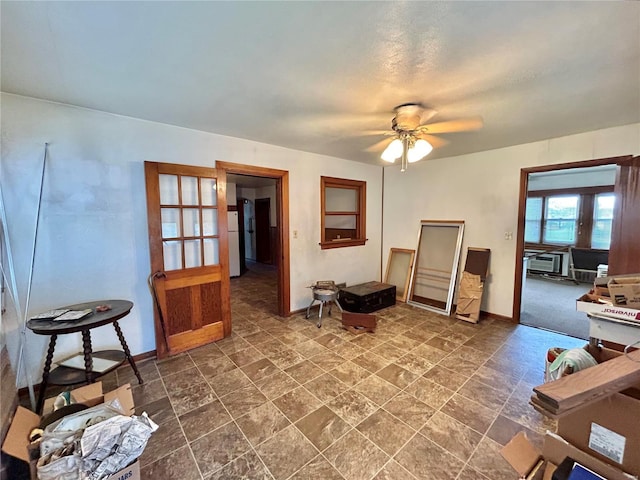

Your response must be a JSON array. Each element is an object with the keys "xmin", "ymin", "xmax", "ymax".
[{"xmin": 27, "ymin": 300, "xmax": 133, "ymax": 335}]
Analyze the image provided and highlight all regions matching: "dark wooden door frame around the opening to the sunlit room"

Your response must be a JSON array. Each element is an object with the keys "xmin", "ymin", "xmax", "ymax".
[{"xmin": 511, "ymin": 155, "xmax": 633, "ymax": 323}]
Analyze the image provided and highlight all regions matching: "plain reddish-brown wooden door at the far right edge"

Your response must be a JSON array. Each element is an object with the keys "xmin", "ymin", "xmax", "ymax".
[{"xmin": 609, "ymin": 157, "xmax": 640, "ymax": 275}]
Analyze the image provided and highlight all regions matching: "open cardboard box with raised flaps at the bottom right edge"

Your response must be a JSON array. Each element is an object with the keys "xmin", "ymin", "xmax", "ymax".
[{"xmin": 500, "ymin": 432, "xmax": 638, "ymax": 480}]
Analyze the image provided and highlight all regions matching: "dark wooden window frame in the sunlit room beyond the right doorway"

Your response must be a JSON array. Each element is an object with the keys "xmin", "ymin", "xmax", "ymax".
[{"xmin": 525, "ymin": 185, "xmax": 614, "ymax": 251}]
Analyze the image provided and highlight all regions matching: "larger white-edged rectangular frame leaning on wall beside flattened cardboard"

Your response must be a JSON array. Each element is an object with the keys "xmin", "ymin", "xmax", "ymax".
[{"xmin": 407, "ymin": 220, "xmax": 464, "ymax": 315}]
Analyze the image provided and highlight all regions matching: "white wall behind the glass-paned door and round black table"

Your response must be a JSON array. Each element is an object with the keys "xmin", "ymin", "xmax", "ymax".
[{"xmin": 0, "ymin": 94, "xmax": 382, "ymax": 381}]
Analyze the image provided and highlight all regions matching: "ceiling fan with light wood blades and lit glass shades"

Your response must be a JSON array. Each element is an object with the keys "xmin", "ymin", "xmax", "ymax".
[{"xmin": 365, "ymin": 103, "xmax": 482, "ymax": 172}]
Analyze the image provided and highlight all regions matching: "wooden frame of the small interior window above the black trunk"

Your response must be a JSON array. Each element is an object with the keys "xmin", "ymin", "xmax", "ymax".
[{"xmin": 320, "ymin": 177, "xmax": 367, "ymax": 250}]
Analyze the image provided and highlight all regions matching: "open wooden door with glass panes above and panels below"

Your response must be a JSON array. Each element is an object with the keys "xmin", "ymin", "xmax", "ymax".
[{"xmin": 144, "ymin": 162, "xmax": 231, "ymax": 358}]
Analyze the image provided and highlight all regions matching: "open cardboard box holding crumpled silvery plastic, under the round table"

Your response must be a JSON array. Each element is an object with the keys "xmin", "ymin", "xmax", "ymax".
[{"xmin": 2, "ymin": 382, "xmax": 140, "ymax": 480}]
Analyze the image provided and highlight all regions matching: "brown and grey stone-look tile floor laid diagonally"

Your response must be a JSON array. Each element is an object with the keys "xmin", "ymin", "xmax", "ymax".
[{"xmin": 111, "ymin": 269, "xmax": 584, "ymax": 480}]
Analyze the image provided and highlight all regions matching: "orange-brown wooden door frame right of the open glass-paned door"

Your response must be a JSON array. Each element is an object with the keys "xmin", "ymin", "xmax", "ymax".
[{"xmin": 215, "ymin": 160, "xmax": 291, "ymax": 317}]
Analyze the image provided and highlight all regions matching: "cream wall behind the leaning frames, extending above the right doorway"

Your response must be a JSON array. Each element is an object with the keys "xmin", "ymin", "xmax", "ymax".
[{"xmin": 383, "ymin": 124, "xmax": 640, "ymax": 317}]
